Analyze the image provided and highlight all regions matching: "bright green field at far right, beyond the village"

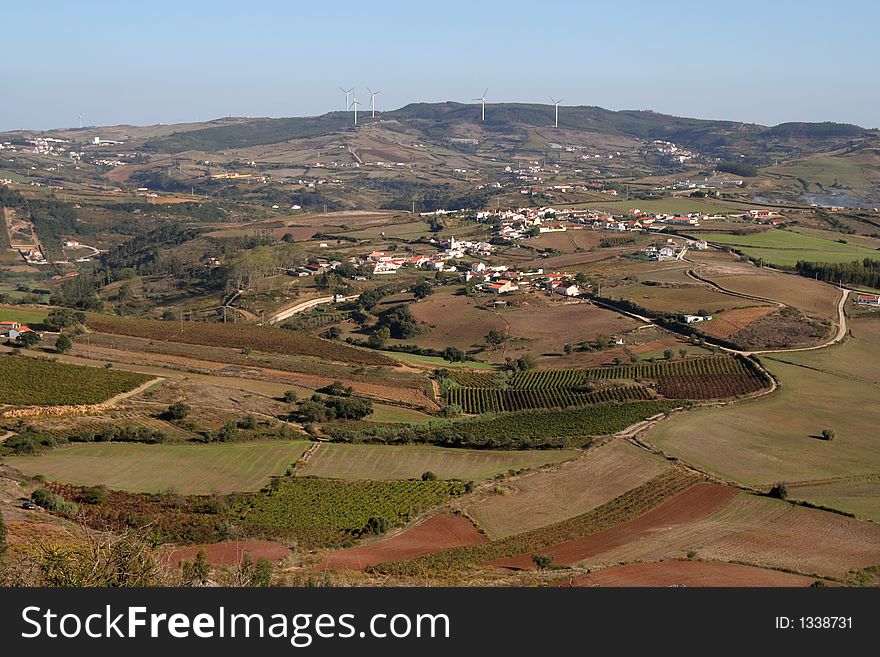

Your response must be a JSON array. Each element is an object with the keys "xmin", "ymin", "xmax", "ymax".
[{"xmin": 693, "ymin": 229, "xmax": 880, "ymax": 266}]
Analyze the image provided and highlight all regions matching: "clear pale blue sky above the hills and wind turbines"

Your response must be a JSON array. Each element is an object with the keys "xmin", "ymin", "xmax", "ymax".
[{"xmin": 0, "ymin": 0, "xmax": 880, "ymax": 130}]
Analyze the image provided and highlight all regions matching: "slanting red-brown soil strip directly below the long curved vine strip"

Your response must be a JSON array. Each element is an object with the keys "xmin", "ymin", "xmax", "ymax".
[{"xmin": 488, "ymin": 484, "xmax": 739, "ymax": 570}]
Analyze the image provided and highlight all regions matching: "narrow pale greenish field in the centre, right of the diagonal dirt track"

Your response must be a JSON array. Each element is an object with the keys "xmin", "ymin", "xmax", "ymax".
[{"xmin": 297, "ymin": 443, "xmax": 580, "ymax": 480}]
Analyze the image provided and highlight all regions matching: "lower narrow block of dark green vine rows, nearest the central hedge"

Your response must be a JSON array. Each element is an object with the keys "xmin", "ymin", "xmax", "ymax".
[{"xmin": 446, "ymin": 385, "xmax": 653, "ymax": 414}]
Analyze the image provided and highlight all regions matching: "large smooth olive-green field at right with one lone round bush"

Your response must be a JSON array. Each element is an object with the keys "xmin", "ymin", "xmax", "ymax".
[{"xmin": 647, "ymin": 354, "xmax": 880, "ymax": 487}]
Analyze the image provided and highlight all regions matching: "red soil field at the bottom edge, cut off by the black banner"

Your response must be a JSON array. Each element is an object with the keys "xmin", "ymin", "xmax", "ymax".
[{"xmin": 561, "ymin": 561, "xmax": 815, "ymax": 586}]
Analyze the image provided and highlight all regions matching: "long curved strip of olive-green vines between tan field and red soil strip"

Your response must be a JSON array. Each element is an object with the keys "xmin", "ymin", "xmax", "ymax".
[{"xmin": 371, "ymin": 468, "xmax": 702, "ymax": 575}]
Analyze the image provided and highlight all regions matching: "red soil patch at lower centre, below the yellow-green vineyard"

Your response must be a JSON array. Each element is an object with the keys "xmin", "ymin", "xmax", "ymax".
[{"xmin": 318, "ymin": 513, "xmax": 486, "ymax": 570}]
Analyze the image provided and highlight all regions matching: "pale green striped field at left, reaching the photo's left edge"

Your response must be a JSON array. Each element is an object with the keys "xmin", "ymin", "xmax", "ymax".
[{"xmin": 6, "ymin": 441, "xmax": 311, "ymax": 495}]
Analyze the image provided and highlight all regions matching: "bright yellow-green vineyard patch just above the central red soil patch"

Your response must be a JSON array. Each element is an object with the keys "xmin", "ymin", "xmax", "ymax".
[{"xmin": 242, "ymin": 478, "xmax": 463, "ymax": 545}]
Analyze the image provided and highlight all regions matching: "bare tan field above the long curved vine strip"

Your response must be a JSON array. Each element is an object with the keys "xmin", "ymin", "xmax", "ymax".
[{"xmin": 466, "ymin": 440, "xmax": 671, "ymax": 538}]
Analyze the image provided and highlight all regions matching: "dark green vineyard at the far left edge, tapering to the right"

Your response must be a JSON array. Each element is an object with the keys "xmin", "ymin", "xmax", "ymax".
[{"xmin": 0, "ymin": 355, "xmax": 153, "ymax": 406}]
